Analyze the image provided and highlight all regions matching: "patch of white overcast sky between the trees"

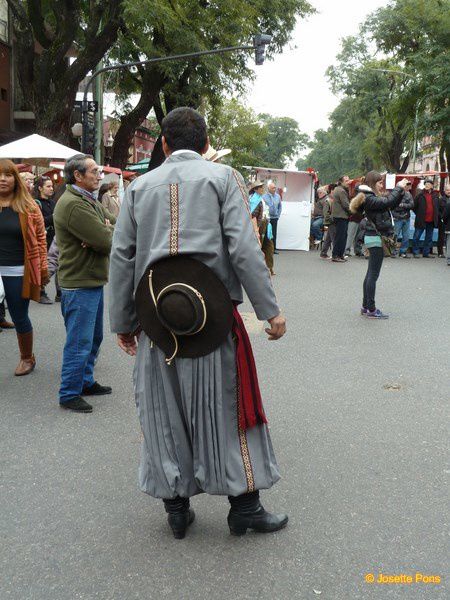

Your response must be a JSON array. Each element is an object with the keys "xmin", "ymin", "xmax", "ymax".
[{"xmin": 247, "ymin": 0, "xmax": 388, "ymax": 135}]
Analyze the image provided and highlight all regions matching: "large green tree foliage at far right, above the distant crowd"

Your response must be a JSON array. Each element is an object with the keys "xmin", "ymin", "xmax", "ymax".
[{"xmin": 298, "ymin": 0, "xmax": 450, "ymax": 181}]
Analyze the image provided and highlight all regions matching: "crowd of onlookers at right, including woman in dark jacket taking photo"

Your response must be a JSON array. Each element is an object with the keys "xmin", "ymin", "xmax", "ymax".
[{"xmin": 310, "ymin": 171, "xmax": 450, "ymax": 319}]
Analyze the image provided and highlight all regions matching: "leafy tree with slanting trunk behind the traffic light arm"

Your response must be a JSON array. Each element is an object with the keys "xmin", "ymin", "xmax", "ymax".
[{"xmin": 107, "ymin": 0, "xmax": 314, "ymax": 167}]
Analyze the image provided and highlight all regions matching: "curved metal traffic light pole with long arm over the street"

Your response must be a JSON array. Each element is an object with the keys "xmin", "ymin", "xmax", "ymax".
[{"xmin": 81, "ymin": 34, "xmax": 272, "ymax": 153}]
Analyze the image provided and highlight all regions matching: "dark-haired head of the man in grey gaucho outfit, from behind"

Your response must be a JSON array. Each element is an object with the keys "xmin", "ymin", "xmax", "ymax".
[{"xmin": 161, "ymin": 106, "xmax": 208, "ymax": 153}]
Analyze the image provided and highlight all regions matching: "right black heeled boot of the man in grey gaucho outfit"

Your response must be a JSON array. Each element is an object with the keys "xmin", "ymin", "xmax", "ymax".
[{"xmin": 228, "ymin": 491, "xmax": 288, "ymax": 535}]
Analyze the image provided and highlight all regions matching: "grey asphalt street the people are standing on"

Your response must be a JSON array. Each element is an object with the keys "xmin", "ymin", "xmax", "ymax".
[{"xmin": 0, "ymin": 252, "xmax": 450, "ymax": 600}]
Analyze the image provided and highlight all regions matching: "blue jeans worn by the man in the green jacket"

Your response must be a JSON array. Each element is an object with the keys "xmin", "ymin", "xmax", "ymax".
[{"xmin": 59, "ymin": 286, "xmax": 103, "ymax": 403}]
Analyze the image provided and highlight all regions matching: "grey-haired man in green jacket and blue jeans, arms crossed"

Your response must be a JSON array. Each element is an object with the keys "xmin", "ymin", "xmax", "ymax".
[{"xmin": 53, "ymin": 154, "xmax": 116, "ymax": 412}]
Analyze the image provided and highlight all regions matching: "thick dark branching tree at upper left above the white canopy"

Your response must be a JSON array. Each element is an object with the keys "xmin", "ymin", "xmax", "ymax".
[{"xmin": 6, "ymin": 0, "xmax": 123, "ymax": 143}]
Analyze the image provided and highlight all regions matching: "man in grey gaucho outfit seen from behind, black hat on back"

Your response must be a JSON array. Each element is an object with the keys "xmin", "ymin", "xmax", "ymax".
[{"xmin": 110, "ymin": 108, "xmax": 288, "ymax": 538}]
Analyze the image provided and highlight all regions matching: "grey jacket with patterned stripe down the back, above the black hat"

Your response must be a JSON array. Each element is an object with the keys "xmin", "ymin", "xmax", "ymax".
[{"xmin": 109, "ymin": 152, "xmax": 280, "ymax": 333}]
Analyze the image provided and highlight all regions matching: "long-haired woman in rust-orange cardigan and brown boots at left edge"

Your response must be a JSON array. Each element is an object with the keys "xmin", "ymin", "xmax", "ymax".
[{"xmin": 0, "ymin": 159, "xmax": 48, "ymax": 375}]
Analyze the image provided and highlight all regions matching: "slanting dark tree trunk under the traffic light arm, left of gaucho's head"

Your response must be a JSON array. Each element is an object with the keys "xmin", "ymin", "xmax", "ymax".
[{"xmin": 111, "ymin": 68, "xmax": 163, "ymax": 169}]
